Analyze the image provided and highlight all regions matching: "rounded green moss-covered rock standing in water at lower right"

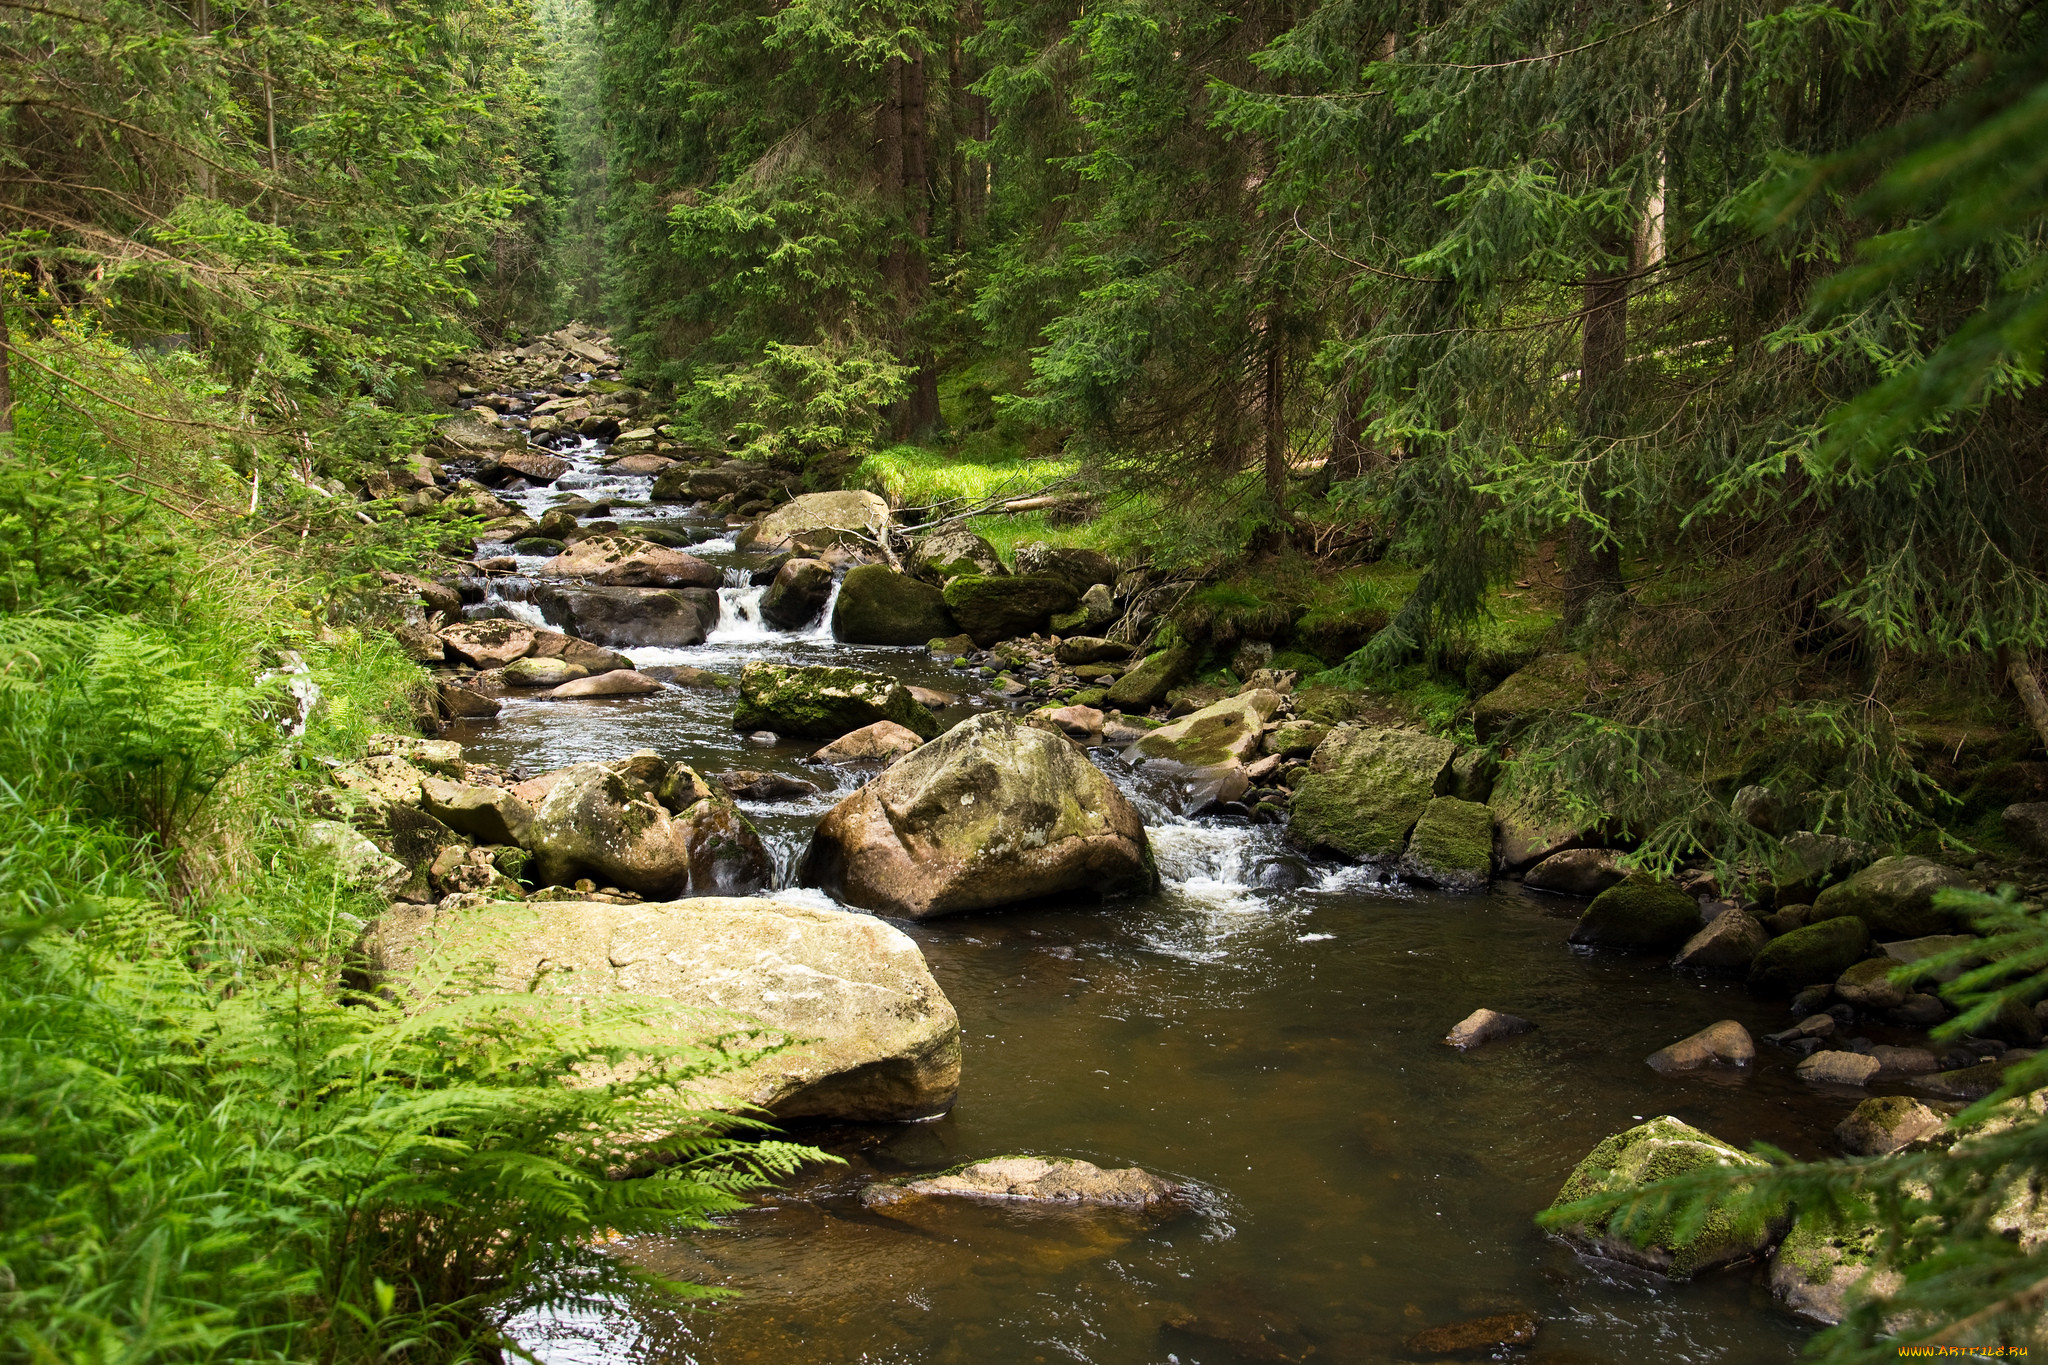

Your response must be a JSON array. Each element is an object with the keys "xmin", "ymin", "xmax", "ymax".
[{"xmin": 1550, "ymin": 1113, "xmax": 1772, "ymax": 1279}]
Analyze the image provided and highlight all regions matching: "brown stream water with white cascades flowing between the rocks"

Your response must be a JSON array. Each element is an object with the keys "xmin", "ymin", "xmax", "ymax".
[{"xmin": 451, "ymin": 401, "xmax": 1826, "ymax": 1365}]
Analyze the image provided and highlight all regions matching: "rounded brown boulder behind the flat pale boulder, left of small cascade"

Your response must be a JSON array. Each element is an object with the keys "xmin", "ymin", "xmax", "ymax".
[{"xmin": 526, "ymin": 749, "xmax": 774, "ymax": 896}]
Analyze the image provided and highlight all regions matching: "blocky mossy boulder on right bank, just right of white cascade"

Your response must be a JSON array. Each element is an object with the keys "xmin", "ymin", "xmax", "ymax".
[{"xmin": 1290, "ymin": 724, "xmax": 1458, "ymax": 860}]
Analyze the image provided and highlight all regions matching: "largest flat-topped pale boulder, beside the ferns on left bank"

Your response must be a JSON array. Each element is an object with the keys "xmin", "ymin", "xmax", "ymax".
[{"xmin": 362, "ymin": 898, "xmax": 961, "ymax": 1124}]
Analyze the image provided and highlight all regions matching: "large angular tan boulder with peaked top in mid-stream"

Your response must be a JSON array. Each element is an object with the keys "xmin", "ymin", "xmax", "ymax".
[{"xmin": 801, "ymin": 712, "xmax": 1159, "ymax": 919}]
